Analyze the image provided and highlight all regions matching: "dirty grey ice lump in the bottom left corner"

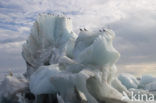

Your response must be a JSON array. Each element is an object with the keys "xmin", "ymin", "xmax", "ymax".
[{"xmin": 0, "ymin": 75, "xmax": 28, "ymax": 103}]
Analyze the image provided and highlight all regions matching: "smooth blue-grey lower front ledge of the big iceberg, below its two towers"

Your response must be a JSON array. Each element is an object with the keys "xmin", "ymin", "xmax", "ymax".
[{"xmin": 30, "ymin": 64, "xmax": 96, "ymax": 103}]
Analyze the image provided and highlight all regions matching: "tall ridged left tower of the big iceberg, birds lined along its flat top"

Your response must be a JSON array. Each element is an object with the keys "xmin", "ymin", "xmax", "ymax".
[{"xmin": 22, "ymin": 14, "xmax": 77, "ymax": 77}]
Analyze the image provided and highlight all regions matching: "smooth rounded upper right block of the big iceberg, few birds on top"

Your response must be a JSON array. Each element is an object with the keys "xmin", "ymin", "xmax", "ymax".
[{"xmin": 74, "ymin": 30, "xmax": 119, "ymax": 65}]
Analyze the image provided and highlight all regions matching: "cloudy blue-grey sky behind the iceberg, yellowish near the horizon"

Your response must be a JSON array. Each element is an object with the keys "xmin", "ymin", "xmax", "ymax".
[{"xmin": 0, "ymin": 0, "xmax": 156, "ymax": 75}]
